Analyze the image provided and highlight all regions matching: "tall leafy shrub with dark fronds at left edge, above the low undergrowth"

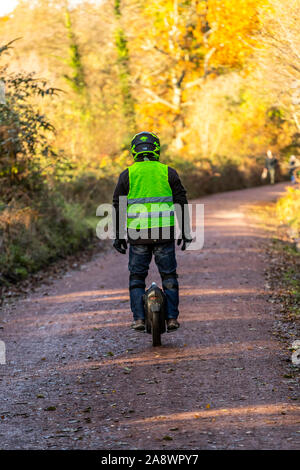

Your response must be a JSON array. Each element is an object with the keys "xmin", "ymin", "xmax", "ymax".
[{"xmin": 0, "ymin": 41, "xmax": 57, "ymax": 202}]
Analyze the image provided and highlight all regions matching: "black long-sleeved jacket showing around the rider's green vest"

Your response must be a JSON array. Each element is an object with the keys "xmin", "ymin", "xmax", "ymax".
[{"xmin": 113, "ymin": 160, "xmax": 190, "ymax": 245}]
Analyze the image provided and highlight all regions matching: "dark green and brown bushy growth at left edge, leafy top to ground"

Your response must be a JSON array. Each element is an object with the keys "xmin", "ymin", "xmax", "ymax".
[{"xmin": 0, "ymin": 44, "xmax": 93, "ymax": 283}]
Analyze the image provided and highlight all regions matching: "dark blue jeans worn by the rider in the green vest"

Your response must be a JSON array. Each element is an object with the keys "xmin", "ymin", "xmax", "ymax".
[{"xmin": 128, "ymin": 241, "xmax": 179, "ymax": 320}]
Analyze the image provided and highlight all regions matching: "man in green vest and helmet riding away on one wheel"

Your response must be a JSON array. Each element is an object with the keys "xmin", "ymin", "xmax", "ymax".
[{"xmin": 113, "ymin": 132, "xmax": 192, "ymax": 331}]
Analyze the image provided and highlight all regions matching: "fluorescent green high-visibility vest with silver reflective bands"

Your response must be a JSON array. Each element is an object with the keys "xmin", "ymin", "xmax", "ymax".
[{"xmin": 127, "ymin": 161, "xmax": 174, "ymax": 230}]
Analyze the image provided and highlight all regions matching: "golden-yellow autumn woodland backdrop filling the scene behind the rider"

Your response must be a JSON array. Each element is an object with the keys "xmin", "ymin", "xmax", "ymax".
[{"xmin": 0, "ymin": 0, "xmax": 300, "ymax": 282}]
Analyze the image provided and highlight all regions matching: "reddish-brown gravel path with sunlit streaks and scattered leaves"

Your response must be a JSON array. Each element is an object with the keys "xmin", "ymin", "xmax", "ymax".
[{"xmin": 0, "ymin": 184, "xmax": 300, "ymax": 449}]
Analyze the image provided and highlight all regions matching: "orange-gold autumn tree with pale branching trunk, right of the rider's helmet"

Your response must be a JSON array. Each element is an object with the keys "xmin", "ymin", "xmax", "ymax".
[{"xmin": 132, "ymin": 0, "xmax": 261, "ymax": 151}]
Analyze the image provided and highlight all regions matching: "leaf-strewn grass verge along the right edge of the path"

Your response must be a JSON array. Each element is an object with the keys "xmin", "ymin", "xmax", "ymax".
[{"xmin": 252, "ymin": 200, "xmax": 300, "ymax": 380}]
